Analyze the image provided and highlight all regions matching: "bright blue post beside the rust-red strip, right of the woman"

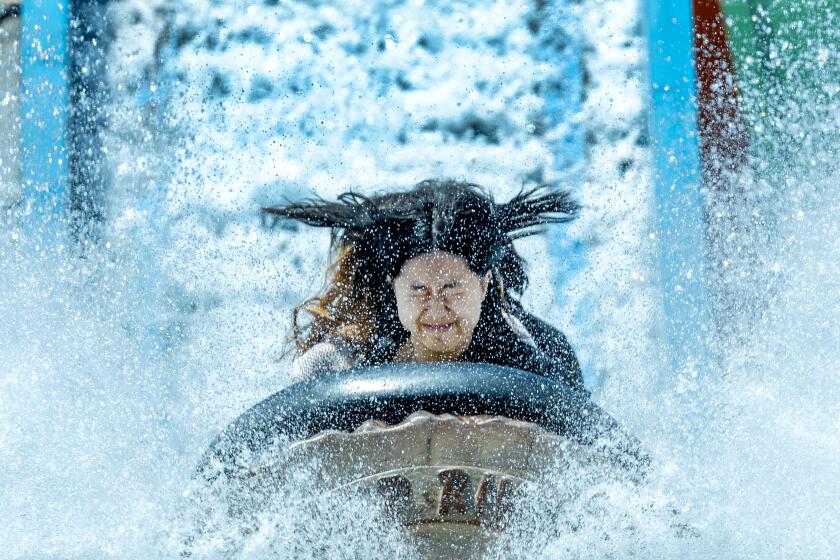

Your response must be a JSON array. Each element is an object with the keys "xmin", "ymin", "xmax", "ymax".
[{"xmin": 646, "ymin": 0, "xmax": 713, "ymax": 372}]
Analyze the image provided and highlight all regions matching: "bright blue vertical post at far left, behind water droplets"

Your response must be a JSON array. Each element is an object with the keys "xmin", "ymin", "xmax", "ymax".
[{"xmin": 21, "ymin": 0, "xmax": 70, "ymax": 233}]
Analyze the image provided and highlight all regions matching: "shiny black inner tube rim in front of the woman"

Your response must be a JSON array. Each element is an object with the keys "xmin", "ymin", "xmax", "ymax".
[{"xmin": 198, "ymin": 363, "xmax": 648, "ymax": 472}]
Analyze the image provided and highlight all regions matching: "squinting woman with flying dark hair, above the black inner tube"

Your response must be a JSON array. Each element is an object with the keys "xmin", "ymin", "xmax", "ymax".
[{"xmin": 264, "ymin": 180, "xmax": 585, "ymax": 391}]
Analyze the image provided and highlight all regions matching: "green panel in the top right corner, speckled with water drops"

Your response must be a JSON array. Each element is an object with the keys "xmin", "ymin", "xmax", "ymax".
[{"xmin": 723, "ymin": 0, "xmax": 840, "ymax": 167}]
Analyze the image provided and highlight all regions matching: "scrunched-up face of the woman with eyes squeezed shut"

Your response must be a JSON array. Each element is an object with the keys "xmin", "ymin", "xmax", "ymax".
[{"xmin": 394, "ymin": 251, "xmax": 490, "ymax": 362}]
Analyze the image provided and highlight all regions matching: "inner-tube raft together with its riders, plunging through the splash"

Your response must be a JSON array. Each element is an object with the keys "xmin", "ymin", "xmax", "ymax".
[{"xmin": 194, "ymin": 180, "xmax": 648, "ymax": 558}]
